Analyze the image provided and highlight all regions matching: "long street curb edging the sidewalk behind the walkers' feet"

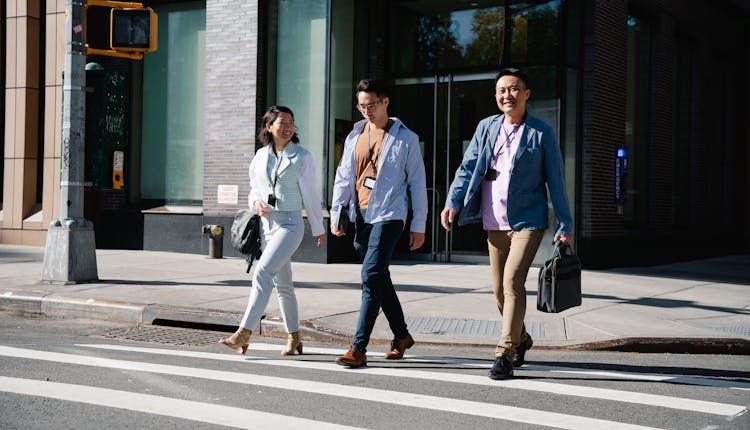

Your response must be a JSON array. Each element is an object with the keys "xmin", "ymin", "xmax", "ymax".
[{"xmin": 0, "ymin": 291, "xmax": 750, "ymax": 355}]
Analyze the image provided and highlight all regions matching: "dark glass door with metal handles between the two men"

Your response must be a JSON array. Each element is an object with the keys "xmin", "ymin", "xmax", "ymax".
[{"xmin": 389, "ymin": 73, "xmax": 498, "ymax": 262}]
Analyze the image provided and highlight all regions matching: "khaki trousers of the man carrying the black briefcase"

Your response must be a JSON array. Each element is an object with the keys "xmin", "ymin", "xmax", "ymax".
[{"xmin": 487, "ymin": 230, "xmax": 544, "ymax": 360}]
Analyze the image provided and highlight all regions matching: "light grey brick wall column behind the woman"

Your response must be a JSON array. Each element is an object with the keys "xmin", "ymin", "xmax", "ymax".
[{"xmin": 203, "ymin": 0, "xmax": 258, "ymax": 216}]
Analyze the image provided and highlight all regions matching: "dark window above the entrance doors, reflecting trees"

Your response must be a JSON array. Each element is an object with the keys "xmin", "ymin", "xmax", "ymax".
[{"xmin": 390, "ymin": 0, "xmax": 560, "ymax": 75}]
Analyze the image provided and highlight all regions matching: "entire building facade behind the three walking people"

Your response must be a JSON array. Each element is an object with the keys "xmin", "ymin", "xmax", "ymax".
[{"xmin": 0, "ymin": 0, "xmax": 750, "ymax": 268}]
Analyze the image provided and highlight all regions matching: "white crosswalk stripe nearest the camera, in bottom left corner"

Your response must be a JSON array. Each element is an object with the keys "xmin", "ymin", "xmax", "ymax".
[{"xmin": 0, "ymin": 376, "xmax": 364, "ymax": 430}]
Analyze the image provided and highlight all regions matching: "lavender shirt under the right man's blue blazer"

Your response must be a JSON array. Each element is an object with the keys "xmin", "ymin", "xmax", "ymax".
[{"xmin": 482, "ymin": 124, "xmax": 524, "ymax": 230}]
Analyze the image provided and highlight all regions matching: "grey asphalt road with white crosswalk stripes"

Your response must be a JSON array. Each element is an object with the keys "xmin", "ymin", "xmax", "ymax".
[{"xmin": 0, "ymin": 314, "xmax": 750, "ymax": 430}]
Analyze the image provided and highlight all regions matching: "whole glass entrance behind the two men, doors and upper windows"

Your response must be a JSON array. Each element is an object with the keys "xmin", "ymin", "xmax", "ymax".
[{"xmin": 328, "ymin": 0, "xmax": 575, "ymax": 261}]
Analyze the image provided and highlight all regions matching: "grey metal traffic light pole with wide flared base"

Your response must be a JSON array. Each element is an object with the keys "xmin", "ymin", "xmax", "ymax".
[{"xmin": 42, "ymin": 0, "xmax": 98, "ymax": 283}]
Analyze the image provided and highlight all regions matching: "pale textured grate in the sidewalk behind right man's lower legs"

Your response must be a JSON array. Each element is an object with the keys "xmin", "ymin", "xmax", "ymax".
[{"xmin": 406, "ymin": 317, "xmax": 544, "ymax": 339}]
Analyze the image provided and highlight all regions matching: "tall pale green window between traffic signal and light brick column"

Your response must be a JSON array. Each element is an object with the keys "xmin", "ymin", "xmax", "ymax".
[{"xmin": 141, "ymin": 2, "xmax": 206, "ymax": 204}]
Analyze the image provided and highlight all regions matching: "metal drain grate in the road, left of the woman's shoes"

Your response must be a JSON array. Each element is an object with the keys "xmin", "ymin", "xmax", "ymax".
[{"xmin": 96, "ymin": 325, "xmax": 230, "ymax": 346}]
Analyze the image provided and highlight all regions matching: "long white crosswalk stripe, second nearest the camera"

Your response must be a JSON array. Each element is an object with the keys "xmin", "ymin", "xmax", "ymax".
[{"xmin": 0, "ymin": 346, "xmax": 664, "ymax": 430}]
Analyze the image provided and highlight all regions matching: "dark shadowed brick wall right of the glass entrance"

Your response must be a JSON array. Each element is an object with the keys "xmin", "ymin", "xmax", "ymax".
[{"xmin": 578, "ymin": 0, "xmax": 750, "ymax": 268}]
